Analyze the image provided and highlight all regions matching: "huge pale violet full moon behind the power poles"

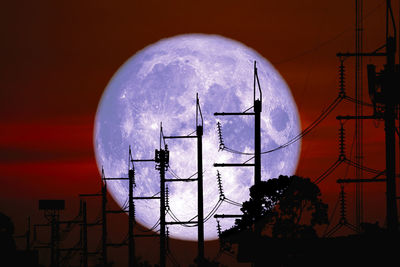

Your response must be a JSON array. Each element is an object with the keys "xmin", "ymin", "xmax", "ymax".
[{"xmin": 94, "ymin": 34, "xmax": 300, "ymax": 241}]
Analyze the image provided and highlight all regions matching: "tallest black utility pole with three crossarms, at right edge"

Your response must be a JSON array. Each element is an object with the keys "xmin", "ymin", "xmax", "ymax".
[{"xmin": 337, "ymin": 0, "xmax": 400, "ymax": 233}]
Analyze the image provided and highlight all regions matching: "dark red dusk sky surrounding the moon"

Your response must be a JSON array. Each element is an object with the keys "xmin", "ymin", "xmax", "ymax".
[{"xmin": 0, "ymin": 0, "xmax": 399, "ymax": 262}]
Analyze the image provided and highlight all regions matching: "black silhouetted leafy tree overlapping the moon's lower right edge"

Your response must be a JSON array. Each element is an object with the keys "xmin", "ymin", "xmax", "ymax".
[{"xmin": 222, "ymin": 175, "xmax": 328, "ymax": 243}]
